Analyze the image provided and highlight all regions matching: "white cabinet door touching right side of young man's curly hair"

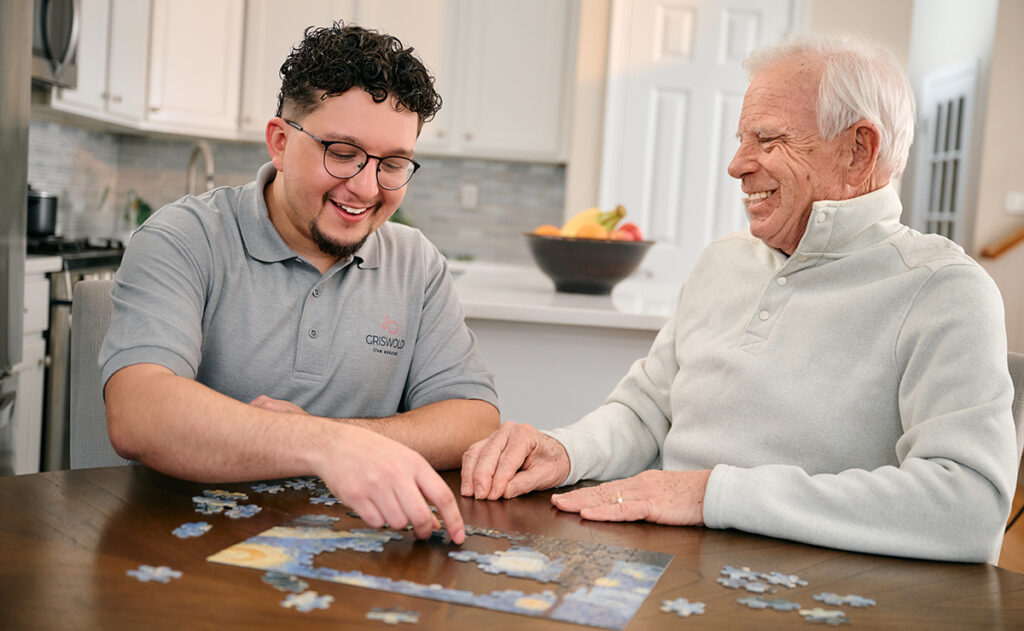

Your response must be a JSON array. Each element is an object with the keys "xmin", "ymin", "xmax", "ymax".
[{"xmin": 358, "ymin": 0, "xmax": 460, "ymax": 153}]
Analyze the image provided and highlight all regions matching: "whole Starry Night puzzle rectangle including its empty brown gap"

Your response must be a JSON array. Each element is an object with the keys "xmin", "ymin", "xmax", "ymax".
[{"xmin": 207, "ymin": 514, "xmax": 672, "ymax": 629}]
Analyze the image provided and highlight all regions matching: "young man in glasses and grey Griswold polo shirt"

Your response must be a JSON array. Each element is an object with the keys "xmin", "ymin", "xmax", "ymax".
[{"xmin": 100, "ymin": 24, "xmax": 498, "ymax": 543}]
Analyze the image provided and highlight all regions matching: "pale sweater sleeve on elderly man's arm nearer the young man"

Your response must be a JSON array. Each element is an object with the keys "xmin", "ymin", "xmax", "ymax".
[{"xmin": 544, "ymin": 290, "xmax": 679, "ymax": 485}]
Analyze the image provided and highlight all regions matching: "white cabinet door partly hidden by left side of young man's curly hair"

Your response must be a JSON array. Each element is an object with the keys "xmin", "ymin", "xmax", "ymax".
[{"xmin": 240, "ymin": 0, "xmax": 353, "ymax": 140}]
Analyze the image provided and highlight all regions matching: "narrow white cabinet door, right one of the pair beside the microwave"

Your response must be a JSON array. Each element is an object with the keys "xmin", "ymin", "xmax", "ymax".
[{"xmin": 106, "ymin": 0, "xmax": 150, "ymax": 124}]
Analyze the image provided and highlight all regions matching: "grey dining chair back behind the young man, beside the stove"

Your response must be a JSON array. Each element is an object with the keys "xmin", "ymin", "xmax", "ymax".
[{"xmin": 69, "ymin": 280, "xmax": 130, "ymax": 469}]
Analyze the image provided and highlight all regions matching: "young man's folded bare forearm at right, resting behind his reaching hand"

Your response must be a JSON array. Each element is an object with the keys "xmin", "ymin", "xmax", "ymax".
[{"xmin": 348, "ymin": 398, "xmax": 500, "ymax": 470}]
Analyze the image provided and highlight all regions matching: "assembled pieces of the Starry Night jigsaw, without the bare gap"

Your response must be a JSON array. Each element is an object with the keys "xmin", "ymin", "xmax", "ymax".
[{"xmin": 207, "ymin": 510, "xmax": 672, "ymax": 629}]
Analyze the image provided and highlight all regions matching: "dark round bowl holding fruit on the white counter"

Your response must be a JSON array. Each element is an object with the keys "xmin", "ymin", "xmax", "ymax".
[{"xmin": 524, "ymin": 233, "xmax": 654, "ymax": 295}]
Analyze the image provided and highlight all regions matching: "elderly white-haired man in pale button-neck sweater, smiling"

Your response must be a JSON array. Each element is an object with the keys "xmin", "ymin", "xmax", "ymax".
[{"xmin": 462, "ymin": 38, "xmax": 1016, "ymax": 561}]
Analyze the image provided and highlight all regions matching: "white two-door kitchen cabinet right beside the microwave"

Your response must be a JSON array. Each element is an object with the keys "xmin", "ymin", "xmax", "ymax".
[{"xmin": 51, "ymin": 0, "xmax": 150, "ymax": 126}]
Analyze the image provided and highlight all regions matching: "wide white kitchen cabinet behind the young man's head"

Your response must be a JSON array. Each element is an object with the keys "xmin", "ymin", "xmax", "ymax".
[{"xmin": 241, "ymin": 0, "xmax": 578, "ymax": 163}]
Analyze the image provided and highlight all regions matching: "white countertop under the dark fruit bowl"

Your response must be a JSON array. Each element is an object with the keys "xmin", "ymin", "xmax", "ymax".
[{"xmin": 449, "ymin": 261, "xmax": 680, "ymax": 331}]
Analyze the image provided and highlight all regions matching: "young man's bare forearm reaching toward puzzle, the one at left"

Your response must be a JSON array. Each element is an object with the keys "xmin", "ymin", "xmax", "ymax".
[{"xmin": 104, "ymin": 364, "xmax": 345, "ymax": 481}]
